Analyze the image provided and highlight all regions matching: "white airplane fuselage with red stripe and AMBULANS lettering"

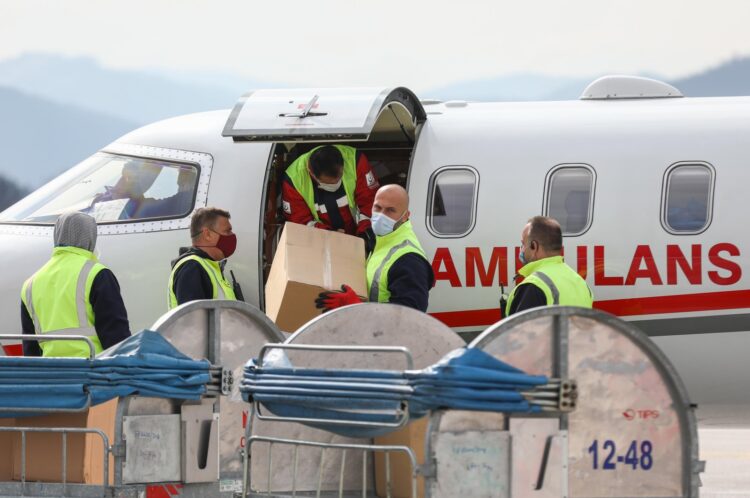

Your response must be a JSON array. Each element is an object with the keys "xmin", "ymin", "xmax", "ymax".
[{"xmin": 0, "ymin": 84, "xmax": 750, "ymax": 409}]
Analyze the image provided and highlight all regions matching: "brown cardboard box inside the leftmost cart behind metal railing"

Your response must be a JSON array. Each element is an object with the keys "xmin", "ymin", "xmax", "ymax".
[{"xmin": 13, "ymin": 399, "xmax": 117, "ymax": 484}]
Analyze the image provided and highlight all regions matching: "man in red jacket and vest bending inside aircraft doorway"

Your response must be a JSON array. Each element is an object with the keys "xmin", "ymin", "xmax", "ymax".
[{"xmin": 282, "ymin": 145, "xmax": 380, "ymax": 254}]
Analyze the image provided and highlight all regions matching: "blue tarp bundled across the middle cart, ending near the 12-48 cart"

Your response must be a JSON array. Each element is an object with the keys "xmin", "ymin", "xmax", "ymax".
[{"xmin": 240, "ymin": 348, "xmax": 548, "ymax": 437}]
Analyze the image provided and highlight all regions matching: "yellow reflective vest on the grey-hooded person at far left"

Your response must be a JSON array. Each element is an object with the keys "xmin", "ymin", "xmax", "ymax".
[{"xmin": 21, "ymin": 247, "xmax": 106, "ymax": 357}]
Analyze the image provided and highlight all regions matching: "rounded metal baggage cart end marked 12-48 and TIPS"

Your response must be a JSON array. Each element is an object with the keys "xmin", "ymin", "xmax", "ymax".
[{"xmin": 426, "ymin": 306, "xmax": 704, "ymax": 498}]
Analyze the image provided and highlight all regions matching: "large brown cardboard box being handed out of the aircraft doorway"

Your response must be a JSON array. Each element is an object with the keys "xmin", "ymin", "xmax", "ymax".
[{"xmin": 266, "ymin": 223, "xmax": 366, "ymax": 332}]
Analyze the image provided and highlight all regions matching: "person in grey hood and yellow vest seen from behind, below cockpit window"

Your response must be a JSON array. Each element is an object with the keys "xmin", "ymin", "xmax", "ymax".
[{"xmin": 21, "ymin": 212, "xmax": 130, "ymax": 357}]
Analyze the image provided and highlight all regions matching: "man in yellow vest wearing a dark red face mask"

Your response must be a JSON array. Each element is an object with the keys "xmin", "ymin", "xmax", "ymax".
[{"xmin": 168, "ymin": 207, "xmax": 238, "ymax": 309}]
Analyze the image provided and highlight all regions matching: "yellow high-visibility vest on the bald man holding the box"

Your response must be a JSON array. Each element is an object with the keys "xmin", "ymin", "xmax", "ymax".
[{"xmin": 367, "ymin": 220, "xmax": 427, "ymax": 303}]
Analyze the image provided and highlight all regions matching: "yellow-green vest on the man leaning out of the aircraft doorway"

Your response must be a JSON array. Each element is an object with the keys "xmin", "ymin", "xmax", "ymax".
[{"xmin": 286, "ymin": 145, "xmax": 359, "ymax": 223}]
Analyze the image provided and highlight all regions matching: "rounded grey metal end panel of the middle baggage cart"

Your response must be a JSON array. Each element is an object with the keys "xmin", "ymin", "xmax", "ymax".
[{"xmin": 246, "ymin": 303, "xmax": 465, "ymax": 496}]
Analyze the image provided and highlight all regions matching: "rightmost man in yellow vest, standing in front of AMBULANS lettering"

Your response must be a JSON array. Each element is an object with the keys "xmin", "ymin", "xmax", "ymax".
[{"xmin": 505, "ymin": 216, "xmax": 593, "ymax": 316}]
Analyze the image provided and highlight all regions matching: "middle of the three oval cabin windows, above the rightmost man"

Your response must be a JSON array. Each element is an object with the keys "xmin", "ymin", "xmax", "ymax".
[{"xmin": 545, "ymin": 165, "xmax": 594, "ymax": 236}]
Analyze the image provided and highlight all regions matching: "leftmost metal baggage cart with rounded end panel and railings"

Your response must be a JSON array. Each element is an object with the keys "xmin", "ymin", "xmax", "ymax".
[{"xmin": 0, "ymin": 301, "xmax": 283, "ymax": 498}]
